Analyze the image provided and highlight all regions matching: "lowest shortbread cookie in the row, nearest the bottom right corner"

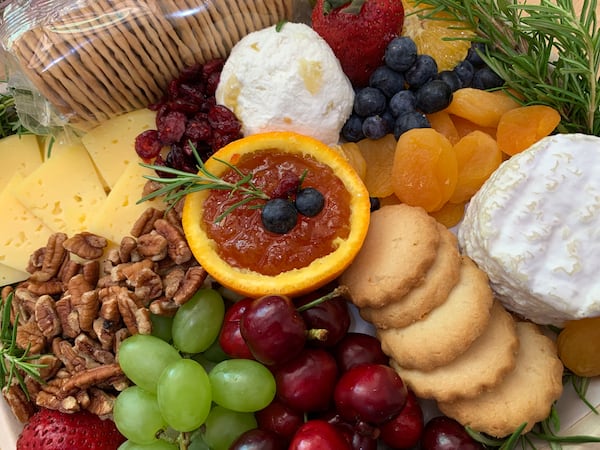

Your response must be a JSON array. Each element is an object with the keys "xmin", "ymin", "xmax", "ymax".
[{"xmin": 438, "ymin": 322, "xmax": 563, "ymax": 437}]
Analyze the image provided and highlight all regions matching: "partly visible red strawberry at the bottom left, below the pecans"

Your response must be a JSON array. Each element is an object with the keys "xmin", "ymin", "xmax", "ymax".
[{"xmin": 17, "ymin": 409, "xmax": 125, "ymax": 450}]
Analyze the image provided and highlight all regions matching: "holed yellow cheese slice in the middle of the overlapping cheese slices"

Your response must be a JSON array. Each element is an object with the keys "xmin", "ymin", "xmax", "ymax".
[{"xmin": 14, "ymin": 145, "xmax": 106, "ymax": 236}]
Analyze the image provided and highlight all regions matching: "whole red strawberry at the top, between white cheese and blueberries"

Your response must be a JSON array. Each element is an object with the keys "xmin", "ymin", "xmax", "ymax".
[{"xmin": 312, "ymin": 0, "xmax": 404, "ymax": 87}]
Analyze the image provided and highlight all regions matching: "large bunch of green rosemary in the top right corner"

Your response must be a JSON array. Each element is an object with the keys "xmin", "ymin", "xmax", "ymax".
[{"xmin": 416, "ymin": 0, "xmax": 600, "ymax": 135}]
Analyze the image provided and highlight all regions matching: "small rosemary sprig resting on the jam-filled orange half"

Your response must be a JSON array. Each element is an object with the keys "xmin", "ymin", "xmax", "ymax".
[{"xmin": 138, "ymin": 143, "xmax": 270, "ymax": 223}]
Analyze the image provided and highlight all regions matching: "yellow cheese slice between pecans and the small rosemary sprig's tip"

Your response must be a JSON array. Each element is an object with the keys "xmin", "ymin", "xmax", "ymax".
[{"xmin": 89, "ymin": 158, "xmax": 166, "ymax": 244}]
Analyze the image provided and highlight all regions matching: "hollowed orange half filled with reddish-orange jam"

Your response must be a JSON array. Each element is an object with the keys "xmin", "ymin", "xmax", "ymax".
[{"xmin": 182, "ymin": 132, "xmax": 370, "ymax": 297}]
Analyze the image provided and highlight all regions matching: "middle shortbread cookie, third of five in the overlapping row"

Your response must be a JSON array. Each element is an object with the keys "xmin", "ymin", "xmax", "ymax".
[{"xmin": 377, "ymin": 256, "xmax": 493, "ymax": 371}]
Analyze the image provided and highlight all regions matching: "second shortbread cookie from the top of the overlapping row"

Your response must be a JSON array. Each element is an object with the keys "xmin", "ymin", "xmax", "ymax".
[{"xmin": 359, "ymin": 224, "xmax": 460, "ymax": 329}]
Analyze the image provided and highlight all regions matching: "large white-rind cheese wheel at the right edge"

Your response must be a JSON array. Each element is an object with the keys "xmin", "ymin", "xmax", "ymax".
[{"xmin": 458, "ymin": 134, "xmax": 600, "ymax": 326}]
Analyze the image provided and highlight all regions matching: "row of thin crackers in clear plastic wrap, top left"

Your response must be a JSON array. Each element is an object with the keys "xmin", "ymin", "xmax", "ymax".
[{"xmin": 11, "ymin": 0, "xmax": 293, "ymax": 125}]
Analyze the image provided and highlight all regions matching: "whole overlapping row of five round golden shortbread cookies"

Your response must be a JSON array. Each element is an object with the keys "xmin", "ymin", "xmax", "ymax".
[{"xmin": 340, "ymin": 204, "xmax": 563, "ymax": 437}]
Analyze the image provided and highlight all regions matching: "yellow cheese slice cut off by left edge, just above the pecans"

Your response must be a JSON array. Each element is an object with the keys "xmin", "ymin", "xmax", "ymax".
[{"xmin": 0, "ymin": 172, "xmax": 52, "ymax": 270}]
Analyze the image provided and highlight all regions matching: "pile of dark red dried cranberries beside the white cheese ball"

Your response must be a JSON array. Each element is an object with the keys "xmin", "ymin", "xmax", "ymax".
[{"xmin": 135, "ymin": 59, "xmax": 241, "ymax": 176}]
